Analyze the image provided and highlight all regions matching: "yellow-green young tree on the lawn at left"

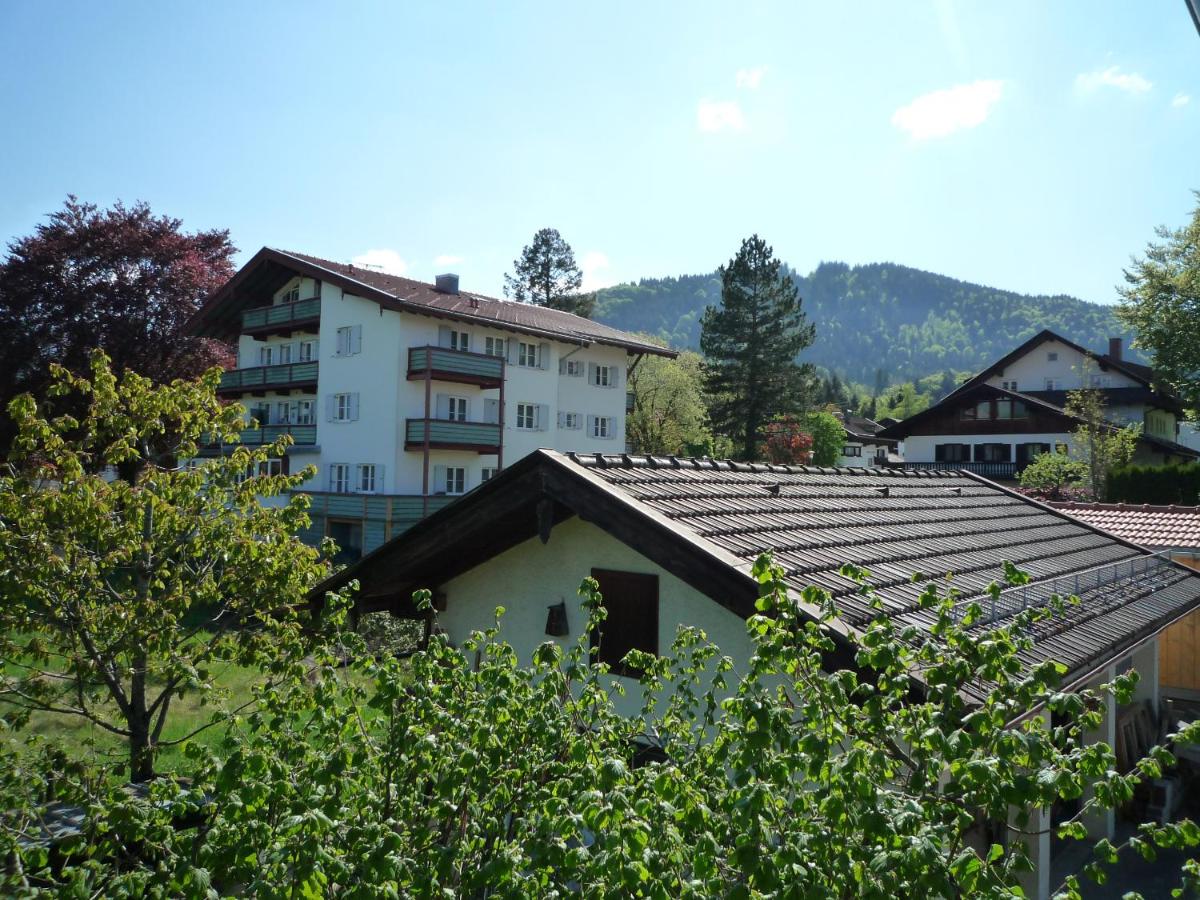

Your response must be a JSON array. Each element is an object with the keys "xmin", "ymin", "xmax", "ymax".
[{"xmin": 0, "ymin": 352, "xmax": 324, "ymax": 781}]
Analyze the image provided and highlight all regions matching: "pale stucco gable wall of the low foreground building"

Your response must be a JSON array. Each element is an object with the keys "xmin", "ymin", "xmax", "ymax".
[{"xmin": 438, "ymin": 517, "xmax": 752, "ymax": 715}]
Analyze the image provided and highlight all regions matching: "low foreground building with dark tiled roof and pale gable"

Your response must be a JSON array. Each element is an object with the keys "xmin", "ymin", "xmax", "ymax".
[{"xmin": 312, "ymin": 450, "xmax": 1200, "ymax": 896}]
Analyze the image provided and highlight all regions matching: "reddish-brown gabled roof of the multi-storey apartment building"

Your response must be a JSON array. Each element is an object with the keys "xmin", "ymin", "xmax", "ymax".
[{"xmin": 187, "ymin": 247, "xmax": 678, "ymax": 356}]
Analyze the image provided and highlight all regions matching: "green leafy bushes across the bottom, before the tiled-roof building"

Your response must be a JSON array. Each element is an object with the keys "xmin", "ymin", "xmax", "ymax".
[{"xmin": 9, "ymin": 558, "xmax": 1200, "ymax": 900}]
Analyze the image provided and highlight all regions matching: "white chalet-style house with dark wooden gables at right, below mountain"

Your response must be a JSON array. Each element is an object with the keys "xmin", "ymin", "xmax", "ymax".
[{"xmin": 880, "ymin": 331, "xmax": 1200, "ymax": 479}]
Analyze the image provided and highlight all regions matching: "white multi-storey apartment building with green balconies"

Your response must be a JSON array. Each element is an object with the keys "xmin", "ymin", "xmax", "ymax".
[{"xmin": 192, "ymin": 247, "xmax": 674, "ymax": 558}]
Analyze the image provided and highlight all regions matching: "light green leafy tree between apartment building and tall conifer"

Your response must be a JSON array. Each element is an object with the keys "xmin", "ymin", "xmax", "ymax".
[{"xmin": 625, "ymin": 350, "xmax": 712, "ymax": 454}]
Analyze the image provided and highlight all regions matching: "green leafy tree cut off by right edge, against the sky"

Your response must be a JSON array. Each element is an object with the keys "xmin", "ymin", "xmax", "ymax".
[{"xmin": 1117, "ymin": 192, "xmax": 1200, "ymax": 414}]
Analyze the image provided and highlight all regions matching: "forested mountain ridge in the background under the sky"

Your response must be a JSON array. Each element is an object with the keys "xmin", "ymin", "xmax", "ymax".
[{"xmin": 593, "ymin": 263, "xmax": 1130, "ymax": 385}]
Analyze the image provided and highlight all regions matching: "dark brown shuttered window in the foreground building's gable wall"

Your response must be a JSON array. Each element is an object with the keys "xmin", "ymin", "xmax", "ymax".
[{"xmin": 592, "ymin": 569, "xmax": 659, "ymax": 676}]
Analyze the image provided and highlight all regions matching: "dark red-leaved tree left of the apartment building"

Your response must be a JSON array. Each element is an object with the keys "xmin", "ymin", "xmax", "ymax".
[{"xmin": 0, "ymin": 196, "xmax": 234, "ymax": 456}]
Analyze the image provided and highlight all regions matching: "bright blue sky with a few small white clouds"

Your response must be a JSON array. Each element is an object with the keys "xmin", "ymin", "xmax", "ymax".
[{"xmin": 0, "ymin": 0, "xmax": 1200, "ymax": 302}]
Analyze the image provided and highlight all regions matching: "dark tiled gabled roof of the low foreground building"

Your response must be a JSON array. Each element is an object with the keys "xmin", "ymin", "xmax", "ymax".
[{"xmin": 312, "ymin": 450, "xmax": 1200, "ymax": 705}]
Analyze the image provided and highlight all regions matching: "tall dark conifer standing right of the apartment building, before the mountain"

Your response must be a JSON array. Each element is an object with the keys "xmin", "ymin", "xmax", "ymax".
[{"xmin": 700, "ymin": 234, "xmax": 815, "ymax": 460}]
